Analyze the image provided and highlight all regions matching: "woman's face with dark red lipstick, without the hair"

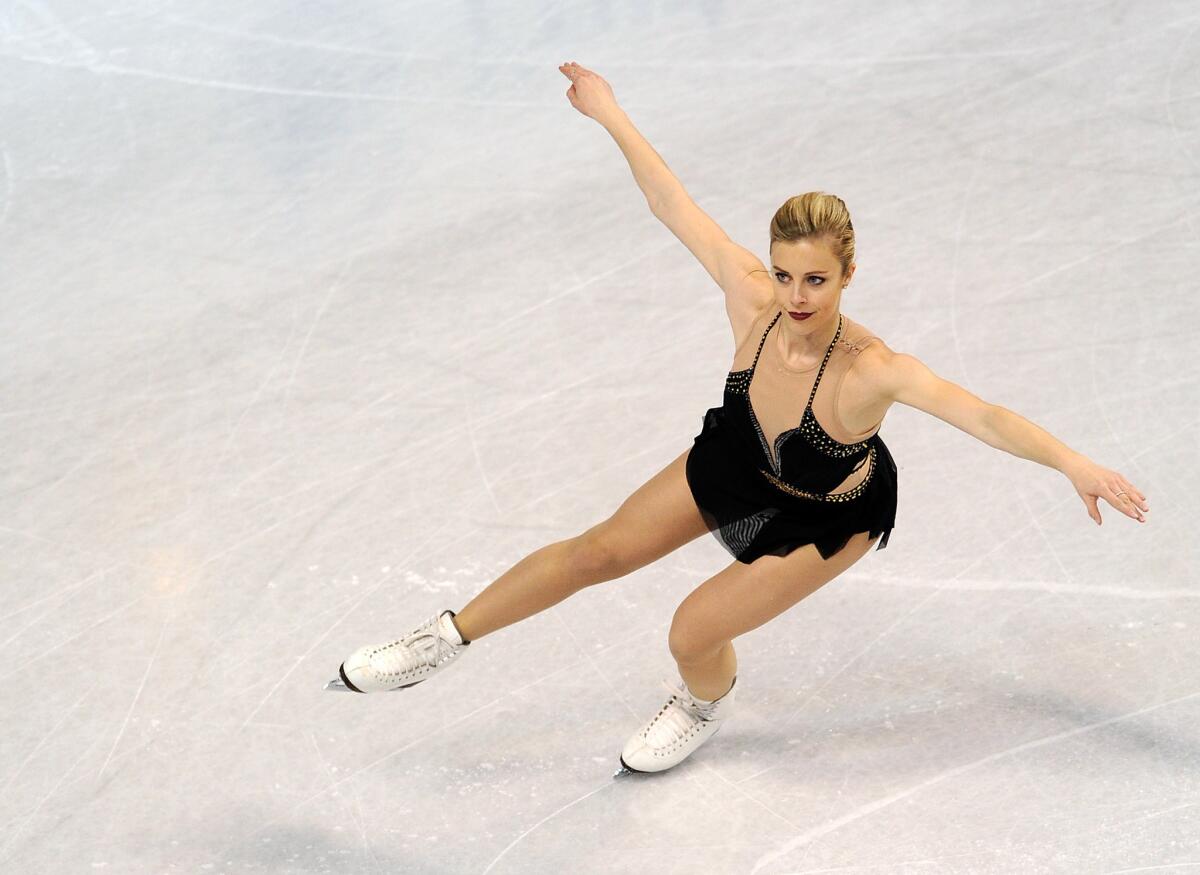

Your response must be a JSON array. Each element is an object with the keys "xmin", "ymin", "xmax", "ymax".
[{"xmin": 770, "ymin": 240, "xmax": 857, "ymax": 332}]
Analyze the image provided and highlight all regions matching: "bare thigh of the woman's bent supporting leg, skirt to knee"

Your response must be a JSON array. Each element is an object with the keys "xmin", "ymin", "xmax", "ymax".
[{"xmin": 670, "ymin": 532, "xmax": 880, "ymax": 655}]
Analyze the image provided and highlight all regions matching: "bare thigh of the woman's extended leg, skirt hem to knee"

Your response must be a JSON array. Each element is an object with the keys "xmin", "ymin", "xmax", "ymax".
[{"xmin": 581, "ymin": 448, "xmax": 708, "ymax": 574}]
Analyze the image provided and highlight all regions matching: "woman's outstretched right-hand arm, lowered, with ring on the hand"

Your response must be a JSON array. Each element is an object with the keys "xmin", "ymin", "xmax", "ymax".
[{"xmin": 856, "ymin": 344, "xmax": 1150, "ymax": 526}]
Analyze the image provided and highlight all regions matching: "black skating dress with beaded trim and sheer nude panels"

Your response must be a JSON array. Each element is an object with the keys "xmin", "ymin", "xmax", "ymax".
[{"xmin": 686, "ymin": 311, "xmax": 896, "ymax": 563}]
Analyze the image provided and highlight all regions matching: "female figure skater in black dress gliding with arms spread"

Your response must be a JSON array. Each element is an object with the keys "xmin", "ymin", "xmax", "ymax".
[{"xmin": 328, "ymin": 62, "xmax": 1150, "ymax": 774}]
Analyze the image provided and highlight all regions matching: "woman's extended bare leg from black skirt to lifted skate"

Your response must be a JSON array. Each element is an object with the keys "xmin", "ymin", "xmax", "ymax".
[{"xmin": 454, "ymin": 448, "xmax": 708, "ymax": 641}]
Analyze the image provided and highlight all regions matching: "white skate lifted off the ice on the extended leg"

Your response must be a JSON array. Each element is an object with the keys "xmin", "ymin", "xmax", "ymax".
[{"xmin": 325, "ymin": 611, "xmax": 470, "ymax": 693}]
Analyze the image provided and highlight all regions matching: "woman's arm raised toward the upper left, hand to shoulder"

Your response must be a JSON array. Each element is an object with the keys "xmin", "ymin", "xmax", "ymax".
[{"xmin": 559, "ymin": 64, "xmax": 767, "ymax": 300}]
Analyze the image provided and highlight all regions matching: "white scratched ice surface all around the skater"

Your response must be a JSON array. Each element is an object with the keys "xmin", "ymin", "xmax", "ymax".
[{"xmin": 0, "ymin": 0, "xmax": 1200, "ymax": 875}]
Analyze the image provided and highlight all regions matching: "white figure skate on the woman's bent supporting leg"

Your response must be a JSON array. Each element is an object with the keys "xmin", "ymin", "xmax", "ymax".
[{"xmin": 613, "ymin": 676, "xmax": 738, "ymax": 778}]
